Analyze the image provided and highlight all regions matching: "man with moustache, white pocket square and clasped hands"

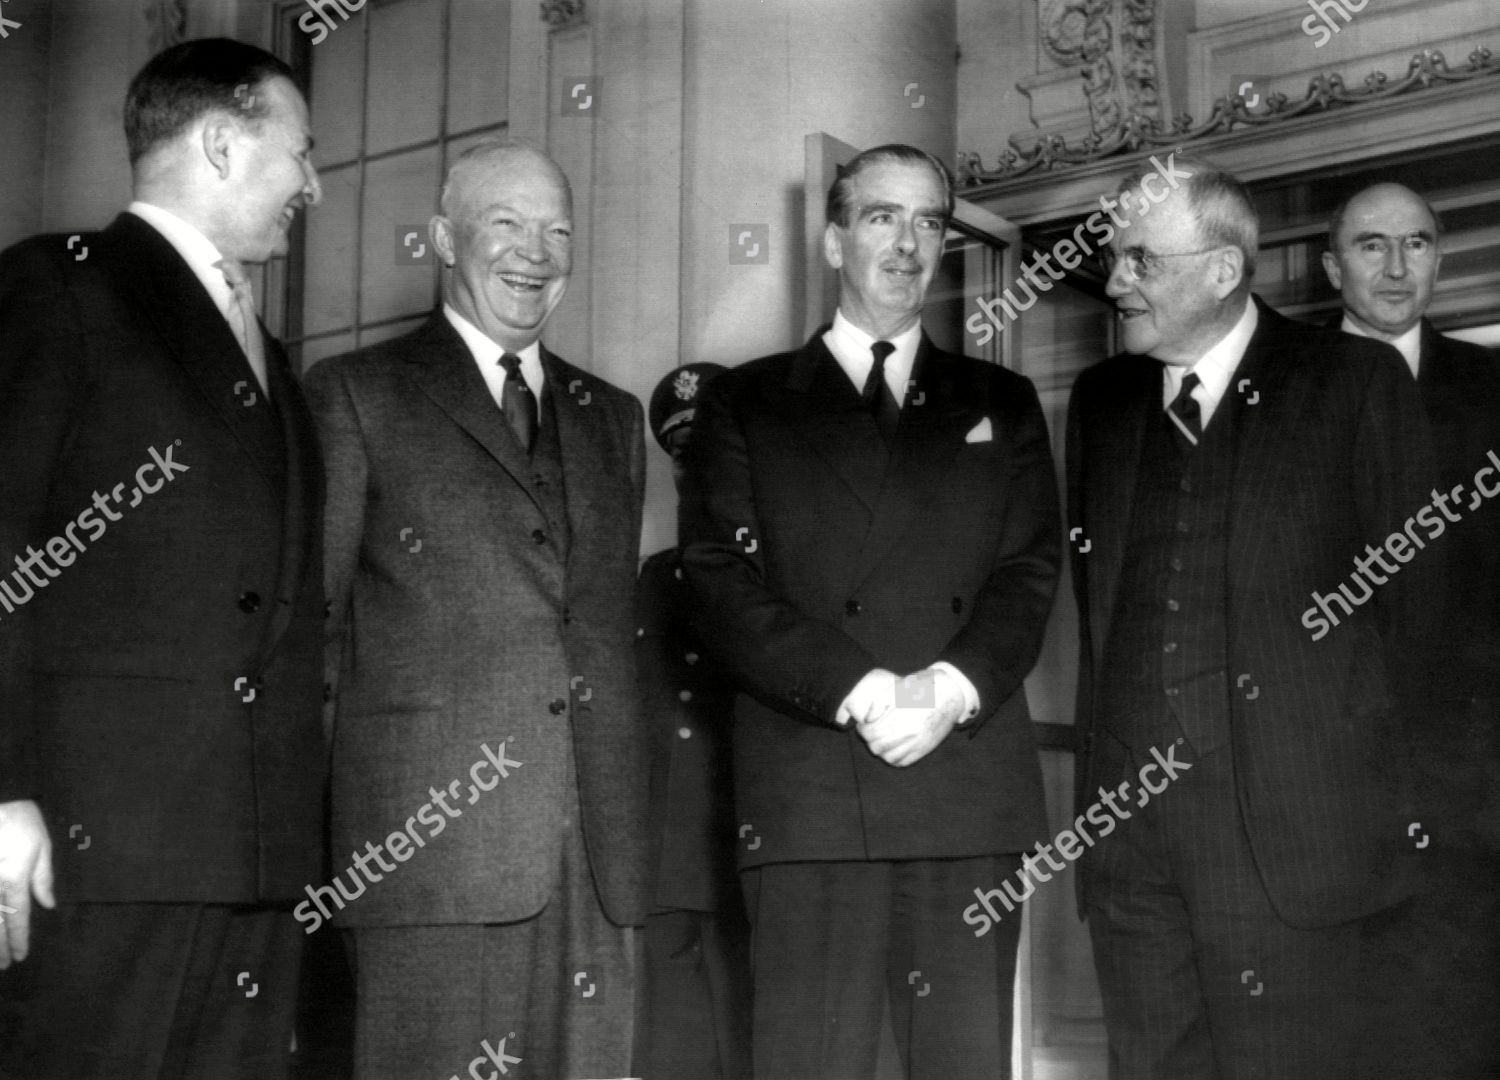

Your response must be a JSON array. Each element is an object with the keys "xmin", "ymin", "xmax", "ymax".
[{"xmin": 680, "ymin": 146, "xmax": 1059, "ymax": 1080}]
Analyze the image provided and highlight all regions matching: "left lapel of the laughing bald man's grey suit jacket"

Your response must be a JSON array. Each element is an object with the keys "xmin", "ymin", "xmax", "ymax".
[{"xmin": 410, "ymin": 312, "xmax": 546, "ymax": 518}]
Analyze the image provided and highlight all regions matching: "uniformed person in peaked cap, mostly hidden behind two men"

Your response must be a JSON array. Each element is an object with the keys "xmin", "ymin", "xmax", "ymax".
[{"xmin": 636, "ymin": 363, "xmax": 750, "ymax": 1080}]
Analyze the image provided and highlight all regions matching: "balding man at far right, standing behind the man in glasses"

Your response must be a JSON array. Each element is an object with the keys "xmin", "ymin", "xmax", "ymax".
[{"xmin": 1323, "ymin": 183, "xmax": 1500, "ymax": 1080}]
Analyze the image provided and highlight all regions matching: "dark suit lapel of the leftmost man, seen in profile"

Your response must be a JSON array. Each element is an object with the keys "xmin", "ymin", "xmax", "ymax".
[{"xmin": 104, "ymin": 213, "xmax": 282, "ymax": 491}]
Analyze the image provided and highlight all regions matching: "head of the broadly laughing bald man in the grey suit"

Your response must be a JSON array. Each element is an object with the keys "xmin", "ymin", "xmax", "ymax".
[{"xmin": 431, "ymin": 141, "xmax": 573, "ymax": 353}]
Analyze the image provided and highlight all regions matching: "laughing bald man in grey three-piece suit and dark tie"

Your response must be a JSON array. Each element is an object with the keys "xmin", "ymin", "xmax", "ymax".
[{"xmin": 299, "ymin": 141, "xmax": 647, "ymax": 1080}]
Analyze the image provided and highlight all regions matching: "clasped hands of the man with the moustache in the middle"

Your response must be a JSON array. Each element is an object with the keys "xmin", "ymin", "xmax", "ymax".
[{"xmin": 834, "ymin": 668, "xmax": 966, "ymax": 768}]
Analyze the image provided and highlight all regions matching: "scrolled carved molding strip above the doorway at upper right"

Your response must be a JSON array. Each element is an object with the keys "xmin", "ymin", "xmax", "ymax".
[{"xmin": 957, "ymin": 46, "xmax": 1500, "ymax": 188}]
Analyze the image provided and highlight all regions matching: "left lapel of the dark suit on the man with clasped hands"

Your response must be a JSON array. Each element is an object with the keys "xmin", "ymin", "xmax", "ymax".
[{"xmin": 771, "ymin": 330, "xmax": 890, "ymax": 513}]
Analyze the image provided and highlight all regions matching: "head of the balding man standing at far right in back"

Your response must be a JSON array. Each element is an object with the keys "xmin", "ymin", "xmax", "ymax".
[{"xmin": 1323, "ymin": 183, "xmax": 1442, "ymax": 341}]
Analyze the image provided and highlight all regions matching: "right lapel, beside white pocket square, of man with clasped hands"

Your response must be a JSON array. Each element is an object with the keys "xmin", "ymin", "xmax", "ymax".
[{"xmin": 840, "ymin": 333, "xmax": 986, "ymax": 588}]
